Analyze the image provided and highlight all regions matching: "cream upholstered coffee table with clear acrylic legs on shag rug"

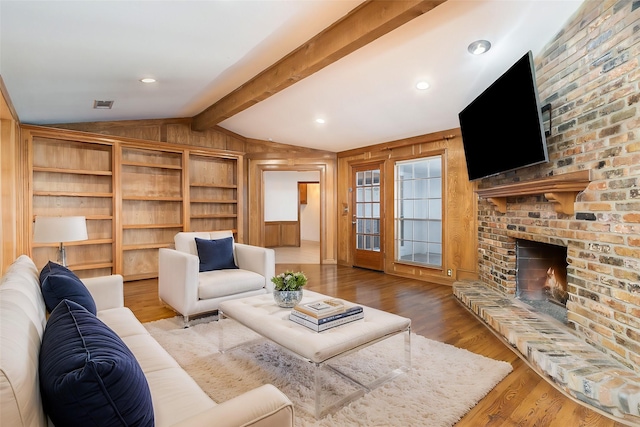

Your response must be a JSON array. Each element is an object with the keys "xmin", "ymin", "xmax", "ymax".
[{"xmin": 219, "ymin": 290, "xmax": 411, "ymax": 418}]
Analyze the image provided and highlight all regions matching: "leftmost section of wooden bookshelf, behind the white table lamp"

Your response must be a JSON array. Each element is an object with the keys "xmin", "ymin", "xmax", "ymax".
[{"xmin": 31, "ymin": 136, "xmax": 114, "ymax": 277}]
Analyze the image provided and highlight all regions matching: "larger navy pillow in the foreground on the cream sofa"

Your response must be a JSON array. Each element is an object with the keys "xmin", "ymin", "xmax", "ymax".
[{"xmin": 39, "ymin": 300, "xmax": 154, "ymax": 427}]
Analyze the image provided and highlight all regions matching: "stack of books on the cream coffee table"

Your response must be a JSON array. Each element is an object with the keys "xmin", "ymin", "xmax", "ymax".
[{"xmin": 289, "ymin": 299, "xmax": 364, "ymax": 332}]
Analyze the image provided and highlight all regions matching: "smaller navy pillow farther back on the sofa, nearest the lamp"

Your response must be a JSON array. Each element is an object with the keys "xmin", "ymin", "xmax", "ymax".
[{"xmin": 40, "ymin": 261, "xmax": 97, "ymax": 314}]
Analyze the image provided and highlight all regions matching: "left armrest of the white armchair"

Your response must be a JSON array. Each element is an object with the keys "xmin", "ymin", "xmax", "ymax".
[{"xmin": 158, "ymin": 248, "xmax": 200, "ymax": 313}]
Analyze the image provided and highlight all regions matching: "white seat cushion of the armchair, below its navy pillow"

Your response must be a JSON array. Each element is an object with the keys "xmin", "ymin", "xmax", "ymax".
[{"xmin": 198, "ymin": 270, "xmax": 265, "ymax": 299}]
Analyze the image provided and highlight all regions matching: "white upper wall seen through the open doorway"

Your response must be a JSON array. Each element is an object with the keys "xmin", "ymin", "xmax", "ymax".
[{"xmin": 263, "ymin": 171, "xmax": 320, "ymax": 222}]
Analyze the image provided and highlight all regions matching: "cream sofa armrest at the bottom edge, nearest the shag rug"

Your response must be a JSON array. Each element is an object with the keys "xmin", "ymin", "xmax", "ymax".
[{"xmin": 168, "ymin": 384, "xmax": 294, "ymax": 427}]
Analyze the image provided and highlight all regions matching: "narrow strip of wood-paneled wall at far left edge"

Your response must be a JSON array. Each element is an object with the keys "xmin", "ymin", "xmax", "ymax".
[{"xmin": 0, "ymin": 77, "xmax": 25, "ymax": 274}]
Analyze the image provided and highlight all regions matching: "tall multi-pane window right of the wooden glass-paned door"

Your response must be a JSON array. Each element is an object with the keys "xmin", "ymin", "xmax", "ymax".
[{"xmin": 394, "ymin": 156, "xmax": 442, "ymax": 267}]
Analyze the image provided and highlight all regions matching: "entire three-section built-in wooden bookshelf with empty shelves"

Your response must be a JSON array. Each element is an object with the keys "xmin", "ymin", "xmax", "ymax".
[{"xmin": 23, "ymin": 125, "xmax": 243, "ymax": 281}]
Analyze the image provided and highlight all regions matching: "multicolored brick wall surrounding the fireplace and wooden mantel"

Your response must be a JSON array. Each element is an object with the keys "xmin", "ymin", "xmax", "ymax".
[{"xmin": 478, "ymin": 0, "xmax": 640, "ymax": 372}]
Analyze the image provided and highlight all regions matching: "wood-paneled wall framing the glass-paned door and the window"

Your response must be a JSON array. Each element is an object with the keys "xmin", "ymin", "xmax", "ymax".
[{"xmin": 337, "ymin": 129, "xmax": 478, "ymax": 284}]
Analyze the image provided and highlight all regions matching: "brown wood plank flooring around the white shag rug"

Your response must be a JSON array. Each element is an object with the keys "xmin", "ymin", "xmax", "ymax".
[{"xmin": 125, "ymin": 264, "xmax": 626, "ymax": 427}]
